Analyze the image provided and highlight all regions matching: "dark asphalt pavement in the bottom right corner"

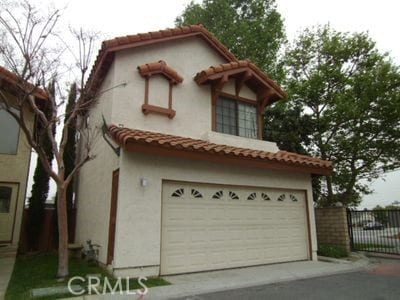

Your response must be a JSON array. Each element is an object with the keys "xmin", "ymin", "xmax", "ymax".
[{"xmin": 175, "ymin": 260, "xmax": 400, "ymax": 300}]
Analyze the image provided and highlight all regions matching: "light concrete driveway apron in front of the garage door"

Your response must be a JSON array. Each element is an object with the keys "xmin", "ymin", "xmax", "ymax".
[{"xmin": 81, "ymin": 255, "xmax": 371, "ymax": 300}]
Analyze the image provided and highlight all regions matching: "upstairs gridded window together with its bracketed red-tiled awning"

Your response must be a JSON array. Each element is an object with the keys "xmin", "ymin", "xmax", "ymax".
[{"xmin": 194, "ymin": 60, "xmax": 287, "ymax": 139}]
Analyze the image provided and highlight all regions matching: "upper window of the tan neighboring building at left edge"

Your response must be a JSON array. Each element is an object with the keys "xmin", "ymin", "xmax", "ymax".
[{"xmin": 0, "ymin": 109, "xmax": 19, "ymax": 154}]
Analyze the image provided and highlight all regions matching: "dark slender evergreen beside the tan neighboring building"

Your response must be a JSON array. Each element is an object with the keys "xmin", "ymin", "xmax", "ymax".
[{"xmin": 26, "ymin": 83, "xmax": 56, "ymax": 251}]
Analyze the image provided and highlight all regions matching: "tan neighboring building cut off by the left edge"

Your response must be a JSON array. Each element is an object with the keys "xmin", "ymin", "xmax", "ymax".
[{"xmin": 0, "ymin": 67, "xmax": 45, "ymax": 247}]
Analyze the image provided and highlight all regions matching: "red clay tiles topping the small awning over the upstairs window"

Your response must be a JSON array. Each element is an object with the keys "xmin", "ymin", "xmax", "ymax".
[{"xmin": 195, "ymin": 60, "xmax": 287, "ymax": 98}]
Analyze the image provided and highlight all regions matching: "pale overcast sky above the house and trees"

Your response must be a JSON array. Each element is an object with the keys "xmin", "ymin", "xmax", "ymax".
[{"xmin": 31, "ymin": 0, "xmax": 400, "ymax": 208}]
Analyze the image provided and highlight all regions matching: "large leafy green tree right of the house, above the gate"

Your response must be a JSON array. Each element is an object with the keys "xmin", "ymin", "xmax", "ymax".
[{"xmin": 282, "ymin": 26, "xmax": 400, "ymax": 206}]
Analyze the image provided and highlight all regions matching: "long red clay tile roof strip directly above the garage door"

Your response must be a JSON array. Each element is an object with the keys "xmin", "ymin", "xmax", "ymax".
[{"xmin": 109, "ymin": 125, "xmax": 332, "ymax": 175}]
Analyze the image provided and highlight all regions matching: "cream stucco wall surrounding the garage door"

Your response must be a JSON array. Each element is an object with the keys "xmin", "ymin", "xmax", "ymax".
[{"xmin": 114, "ymin": 151, "xmax": 316, "ymax": 276}]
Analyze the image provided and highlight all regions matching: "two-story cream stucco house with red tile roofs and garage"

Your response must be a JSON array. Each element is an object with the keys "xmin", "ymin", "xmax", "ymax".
[{"xmin": 76, "ymin": 25, "xmax": 332, "ymax": 276}]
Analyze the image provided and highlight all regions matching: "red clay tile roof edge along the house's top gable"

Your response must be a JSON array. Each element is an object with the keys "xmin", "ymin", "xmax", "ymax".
[{"xmin": 87, "ymin": 25, "xmax": 237, "ymax": 92}]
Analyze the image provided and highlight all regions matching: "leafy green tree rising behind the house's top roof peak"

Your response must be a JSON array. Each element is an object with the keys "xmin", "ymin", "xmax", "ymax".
[{"xmin": 176, "ymin": 0, "xmax": 285, "ymax": 80}]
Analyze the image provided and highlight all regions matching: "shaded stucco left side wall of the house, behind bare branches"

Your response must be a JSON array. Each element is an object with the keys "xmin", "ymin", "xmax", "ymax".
[{"xmin": 75, "ymin": 62, "xmax": 119, "ymax": 263}]
